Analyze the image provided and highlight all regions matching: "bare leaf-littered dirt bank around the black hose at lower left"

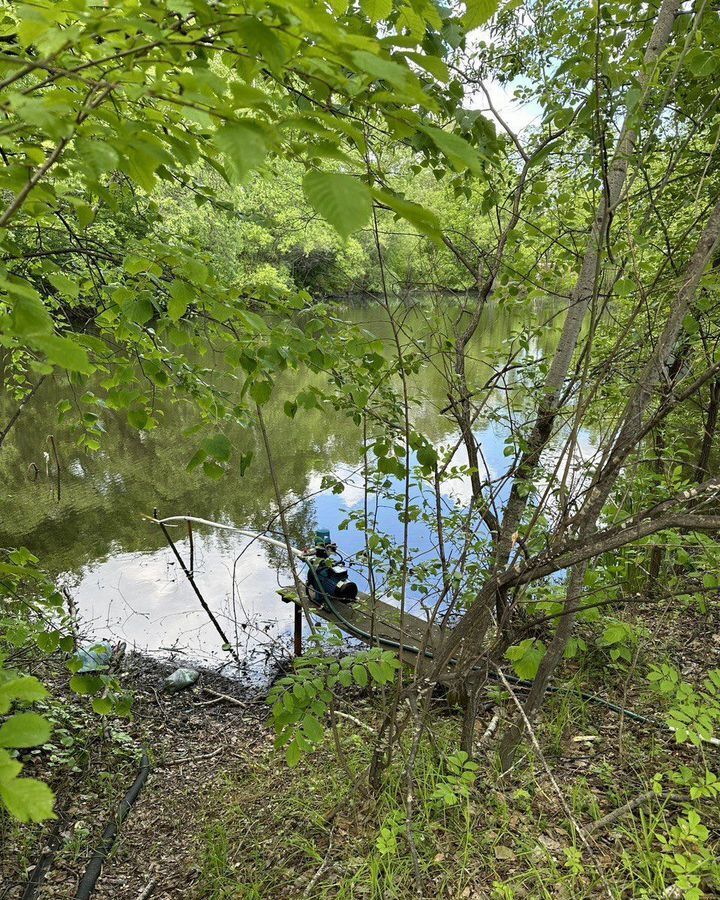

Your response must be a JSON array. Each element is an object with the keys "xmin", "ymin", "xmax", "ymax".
[{"xmin": 0, "ymin": 656, "xmax": 273, "ymax": 900}]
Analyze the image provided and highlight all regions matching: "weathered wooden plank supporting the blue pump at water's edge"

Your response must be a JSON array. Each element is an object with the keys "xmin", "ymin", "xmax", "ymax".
[{"xmin": 278, "ymin": 588, "xmax": 441, "ymax": 662}]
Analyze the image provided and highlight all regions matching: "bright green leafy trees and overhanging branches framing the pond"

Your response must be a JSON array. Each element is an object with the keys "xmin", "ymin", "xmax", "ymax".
[{"xmin": 0, "ymin": 0, "xmax": 720, "ymax": 898}]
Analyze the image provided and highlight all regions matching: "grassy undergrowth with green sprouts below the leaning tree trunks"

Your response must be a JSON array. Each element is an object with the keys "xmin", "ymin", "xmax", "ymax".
[{"xmin": 187, "ymin": 696, "xmax": 720, "ymax": 900}]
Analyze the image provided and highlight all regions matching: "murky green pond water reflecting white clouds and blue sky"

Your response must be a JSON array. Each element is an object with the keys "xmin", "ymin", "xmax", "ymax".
[{"xmin": 0, "ymin": 301, "xmax": 572, "ymax": 682}]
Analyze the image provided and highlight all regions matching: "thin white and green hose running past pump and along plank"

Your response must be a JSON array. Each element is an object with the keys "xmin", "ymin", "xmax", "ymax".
[{"xmin": 150, "ymin": 516, "xmax": 665, "ymax": 725}]
